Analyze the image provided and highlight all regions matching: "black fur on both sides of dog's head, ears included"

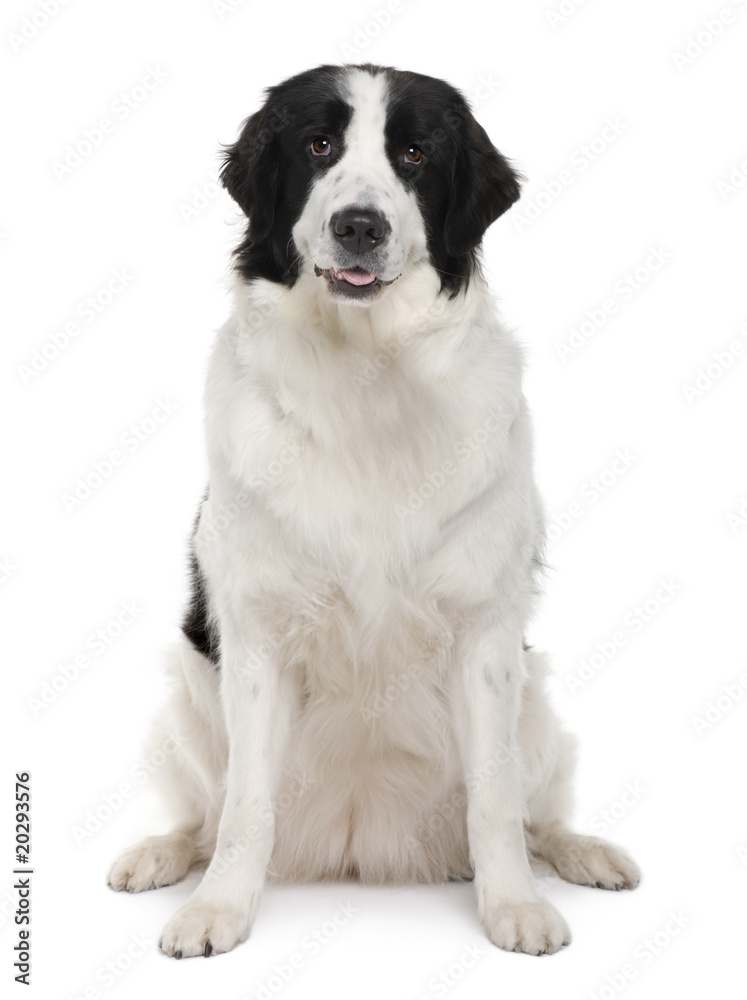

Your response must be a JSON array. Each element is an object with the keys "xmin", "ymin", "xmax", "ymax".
[{"xmin": 221, "ymin": 64, "xmax": 520, "ymax": 294}]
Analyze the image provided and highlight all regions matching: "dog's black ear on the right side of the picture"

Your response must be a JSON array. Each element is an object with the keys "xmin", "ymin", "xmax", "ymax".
[{"xmin": 444, "ymin": 112, "xmax": 522, "ymax": 257}]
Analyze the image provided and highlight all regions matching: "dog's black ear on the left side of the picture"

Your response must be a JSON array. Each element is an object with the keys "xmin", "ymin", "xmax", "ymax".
[{"xmin": 220, "ymin": 103, "xmax": 287, "ymax": 243}]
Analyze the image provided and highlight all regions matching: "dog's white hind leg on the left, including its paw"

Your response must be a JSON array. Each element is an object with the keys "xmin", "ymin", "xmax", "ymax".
[{"xmin": 107, "ymin": 639, "xmax": 227, "ymax": 892}]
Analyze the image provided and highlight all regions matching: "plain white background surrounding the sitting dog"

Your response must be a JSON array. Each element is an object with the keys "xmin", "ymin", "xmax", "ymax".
[{"xmin": 0, "ymin": 0, "xmax": 747, "ymax": 1000}]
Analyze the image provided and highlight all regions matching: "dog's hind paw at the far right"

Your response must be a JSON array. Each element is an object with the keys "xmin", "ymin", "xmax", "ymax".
[{"xmin": 550, "ymin": 833, "xmax": 641, "ymax": 889}]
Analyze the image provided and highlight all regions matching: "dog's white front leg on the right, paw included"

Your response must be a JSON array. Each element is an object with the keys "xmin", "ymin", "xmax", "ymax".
[{"xmin": 460, "ymin": 614, "xmax": 570, "ymax": 955}]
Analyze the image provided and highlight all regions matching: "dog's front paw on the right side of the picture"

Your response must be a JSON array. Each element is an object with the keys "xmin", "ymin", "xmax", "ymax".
[{"xmin": 482, "ymin": 899, "xmax": 571, "ymax": 955}]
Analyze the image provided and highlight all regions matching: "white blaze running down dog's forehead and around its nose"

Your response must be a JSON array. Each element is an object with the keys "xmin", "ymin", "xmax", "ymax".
[{"xmin": 293, "ymin": 70, "xmax": 428, "ymax": 281}]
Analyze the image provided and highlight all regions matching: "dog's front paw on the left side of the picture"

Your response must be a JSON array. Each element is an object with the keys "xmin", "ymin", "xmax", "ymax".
[{"xmin": 158, "ymin": 899, "xmax": 252, "ymax": 958}]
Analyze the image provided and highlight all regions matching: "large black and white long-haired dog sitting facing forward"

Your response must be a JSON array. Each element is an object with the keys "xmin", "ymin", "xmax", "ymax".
[{"xmin": 108, "ymin": 64, "xmax": 640, "ymax": 958}]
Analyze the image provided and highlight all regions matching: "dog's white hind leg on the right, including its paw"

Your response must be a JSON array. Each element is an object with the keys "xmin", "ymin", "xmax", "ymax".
[{"xmin": 519, "ymin": 650, "xmax": 641, "ymax": 889}]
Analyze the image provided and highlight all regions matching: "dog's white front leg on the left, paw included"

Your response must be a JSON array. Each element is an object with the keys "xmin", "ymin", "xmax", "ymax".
[{"xmin": 160, "ymin": 621, "xmax": 296, "ymax": 958}]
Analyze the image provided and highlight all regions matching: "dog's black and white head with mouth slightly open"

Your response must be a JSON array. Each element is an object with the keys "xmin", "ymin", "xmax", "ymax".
[{"xmin": 221, "ymin": 65, "xmax": 519, "ymax": 305}]
